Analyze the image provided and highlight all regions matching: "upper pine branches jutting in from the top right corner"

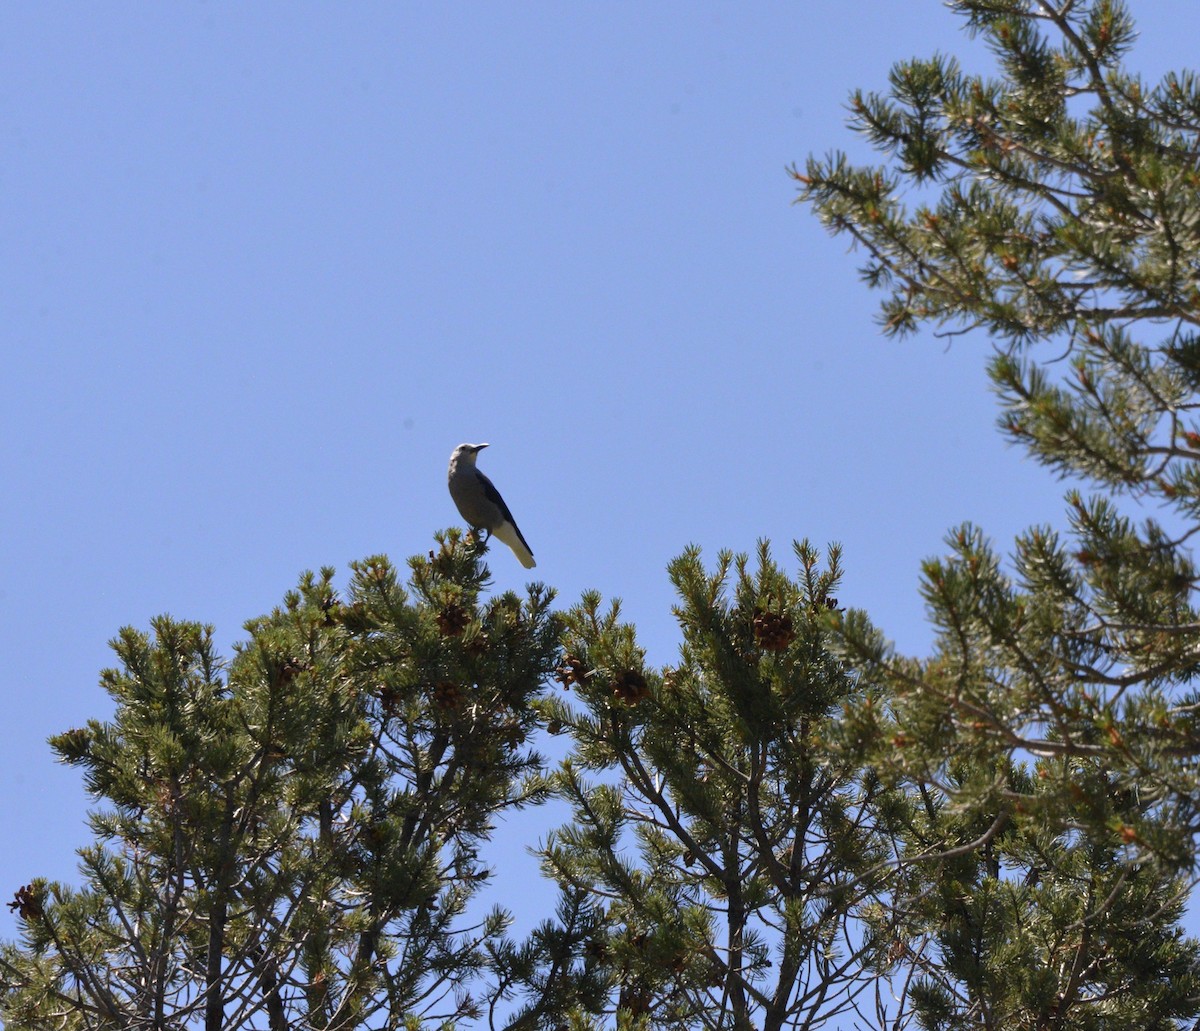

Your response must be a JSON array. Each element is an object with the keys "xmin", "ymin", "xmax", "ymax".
[{"xmin": 793, "ymin": 0, "xmax": 1200, "ymax": 515}]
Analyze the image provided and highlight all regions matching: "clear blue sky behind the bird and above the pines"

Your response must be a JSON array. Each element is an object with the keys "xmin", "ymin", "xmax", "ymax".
[{"xmin": 0, "ymin": 0, "xmax": 1200, "ymax": 937}]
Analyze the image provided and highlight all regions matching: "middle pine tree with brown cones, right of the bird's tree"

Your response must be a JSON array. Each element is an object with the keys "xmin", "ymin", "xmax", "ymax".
[{"xmin": 501, "ymin": 544, "xmax": 912, "ymax": 1029}]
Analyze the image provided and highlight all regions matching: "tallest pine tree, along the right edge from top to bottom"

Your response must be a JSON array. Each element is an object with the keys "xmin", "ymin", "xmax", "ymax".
[{"xmin": 793, "ymin": 0, "xmax": 1200, "ymax": 1029}]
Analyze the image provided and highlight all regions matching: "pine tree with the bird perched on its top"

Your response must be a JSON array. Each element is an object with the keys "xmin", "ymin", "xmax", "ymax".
[{"xmin": 0, "ymin": 535, "xmax": 558, "ymax": 1031}]
